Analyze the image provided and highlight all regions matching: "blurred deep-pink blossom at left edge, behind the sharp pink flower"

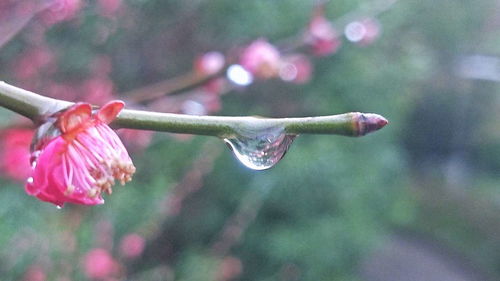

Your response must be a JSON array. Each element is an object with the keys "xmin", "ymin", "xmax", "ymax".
[{"xmin": 0, "ymin": 128, "xmax": 34, "ymax": 181}]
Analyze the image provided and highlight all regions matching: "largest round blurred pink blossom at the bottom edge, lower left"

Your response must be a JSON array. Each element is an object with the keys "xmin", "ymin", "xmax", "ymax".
[{"xmin": 82, "ymin": 248, "xmax": 120, "ymax": 280}]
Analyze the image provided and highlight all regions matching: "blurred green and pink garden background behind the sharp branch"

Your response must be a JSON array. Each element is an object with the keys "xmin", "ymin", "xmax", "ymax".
[{"xmin": 0, "ymin": 0, "xmax": 500, "ymax": 281}]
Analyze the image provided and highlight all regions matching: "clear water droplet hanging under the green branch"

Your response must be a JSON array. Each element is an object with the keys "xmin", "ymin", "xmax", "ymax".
[{"xmin": 224, "ymin": 128, "xmax": 296, "ymax": 170}]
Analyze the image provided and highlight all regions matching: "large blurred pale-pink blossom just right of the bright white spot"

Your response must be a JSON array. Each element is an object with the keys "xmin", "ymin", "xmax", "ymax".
[{"xmin": 240, "ymin": 39, "xmax": 280, "ymax": 79}]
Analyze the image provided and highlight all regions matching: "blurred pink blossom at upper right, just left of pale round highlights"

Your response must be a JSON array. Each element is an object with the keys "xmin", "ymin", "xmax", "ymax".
[{"xmin": 305, "ymin": 12, "xmax": 342, "ymax": 56}]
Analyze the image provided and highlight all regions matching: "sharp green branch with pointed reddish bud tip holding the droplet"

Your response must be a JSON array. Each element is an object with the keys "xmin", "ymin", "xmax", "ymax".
[{"xmin": 0, "ymin": 81, "xmax": 388, "ymax": 138}]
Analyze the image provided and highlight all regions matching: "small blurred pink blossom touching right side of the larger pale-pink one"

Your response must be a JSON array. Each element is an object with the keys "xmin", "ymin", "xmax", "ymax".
[{"xmin": 280, "ymin": 54, "xmax": 313, "ymax": 84}]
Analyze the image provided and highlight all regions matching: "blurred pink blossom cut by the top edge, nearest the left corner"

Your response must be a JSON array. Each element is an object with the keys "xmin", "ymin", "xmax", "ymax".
[{"xmin": 42, "ymin": 0, "xmax": 83, "ymax": 26}]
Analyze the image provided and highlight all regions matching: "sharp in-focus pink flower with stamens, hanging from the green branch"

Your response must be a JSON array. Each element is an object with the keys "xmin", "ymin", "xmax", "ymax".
[{"xmin": 26, "ymin": 101, "xmax": 135, "ymax": 206}]
